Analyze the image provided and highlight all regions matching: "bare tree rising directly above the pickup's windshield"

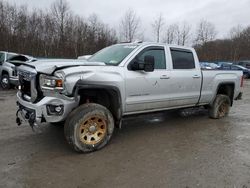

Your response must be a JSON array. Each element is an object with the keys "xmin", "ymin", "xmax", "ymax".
[{"xmin": 120, "ymin": 9, "xmax": 140, "ymax": 42}]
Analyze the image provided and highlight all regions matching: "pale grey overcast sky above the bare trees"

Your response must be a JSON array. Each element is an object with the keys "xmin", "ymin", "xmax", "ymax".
[{"xmin": 6, "ymin": 0, "xmax": 250, "ymax": 40}]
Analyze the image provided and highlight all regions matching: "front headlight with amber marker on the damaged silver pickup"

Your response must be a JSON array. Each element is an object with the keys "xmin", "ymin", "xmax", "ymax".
[{"xmin": 39, "ymin": 74, "xmax": 63, "ymax": 90}]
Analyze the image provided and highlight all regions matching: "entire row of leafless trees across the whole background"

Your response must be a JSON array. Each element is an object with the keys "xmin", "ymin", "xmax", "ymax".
[{"xmin": 0, "ymin": 0, "xmax": 250, "ymax": 61}]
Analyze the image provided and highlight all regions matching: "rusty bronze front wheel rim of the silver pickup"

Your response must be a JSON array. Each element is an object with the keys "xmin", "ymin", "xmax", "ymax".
[{"xmin": 79, "ymin": 116, "xmax": 107, "ymax": 145}]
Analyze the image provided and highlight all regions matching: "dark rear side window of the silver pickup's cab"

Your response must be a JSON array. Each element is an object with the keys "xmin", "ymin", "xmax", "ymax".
[{"xmin": 171, "ymin": 49, "xmax": 195, "ymax": 69}]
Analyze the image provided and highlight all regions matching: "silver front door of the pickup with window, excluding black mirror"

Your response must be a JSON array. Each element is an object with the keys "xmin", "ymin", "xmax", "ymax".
[{"xmin": 125, "ymin": 46, "xmax": 169, "ymax": 114}]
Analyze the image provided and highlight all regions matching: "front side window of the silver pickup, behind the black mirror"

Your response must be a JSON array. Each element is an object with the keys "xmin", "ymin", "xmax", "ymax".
[{"xmin": 137, "ymin": 48, "xmax": 166, "ymax": 69}]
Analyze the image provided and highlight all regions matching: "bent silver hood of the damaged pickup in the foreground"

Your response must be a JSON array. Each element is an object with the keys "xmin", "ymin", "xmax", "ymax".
[{"xmin": 20, "ymin": 59, "xmax": 105, "ymax": 74}]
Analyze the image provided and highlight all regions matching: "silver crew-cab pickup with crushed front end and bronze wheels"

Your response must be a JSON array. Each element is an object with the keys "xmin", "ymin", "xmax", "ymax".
[{"xmin": 17, "ymin": 43, "xmax": 243, "ymax": 152}]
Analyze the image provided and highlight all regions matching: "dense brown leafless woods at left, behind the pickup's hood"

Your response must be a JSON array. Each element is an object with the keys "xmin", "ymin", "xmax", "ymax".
[{"xmin": 0, "ymin": 0, "xmax": 117, "ymax": 58}]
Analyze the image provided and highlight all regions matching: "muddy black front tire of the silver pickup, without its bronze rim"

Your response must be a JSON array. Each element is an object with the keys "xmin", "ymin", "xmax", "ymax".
[{"xmin": 64, "ymin": 103, "xmax": 114, "ymax": 153}]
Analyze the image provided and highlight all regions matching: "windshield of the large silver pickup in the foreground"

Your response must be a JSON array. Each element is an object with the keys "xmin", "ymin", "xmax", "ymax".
[{"xmin": 88, "ymin": 44, "xmax": 138, "ymax": 65}]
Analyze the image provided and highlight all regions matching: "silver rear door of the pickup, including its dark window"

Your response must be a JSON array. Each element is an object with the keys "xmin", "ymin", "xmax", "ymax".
[{"xmin": 168, "ymin": 48, "xmax": 202, "ymax": 107}]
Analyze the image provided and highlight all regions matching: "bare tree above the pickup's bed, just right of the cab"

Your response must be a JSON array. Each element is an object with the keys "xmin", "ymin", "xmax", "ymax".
[{"xmin": 195, "ymin": 20, "xmax": 216, "ymax": 45}]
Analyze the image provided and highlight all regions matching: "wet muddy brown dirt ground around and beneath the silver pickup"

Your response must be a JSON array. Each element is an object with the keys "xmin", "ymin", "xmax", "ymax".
[{"xmin": 0, "ymin": 81, "xmax": 250, "ymax": 188}]
